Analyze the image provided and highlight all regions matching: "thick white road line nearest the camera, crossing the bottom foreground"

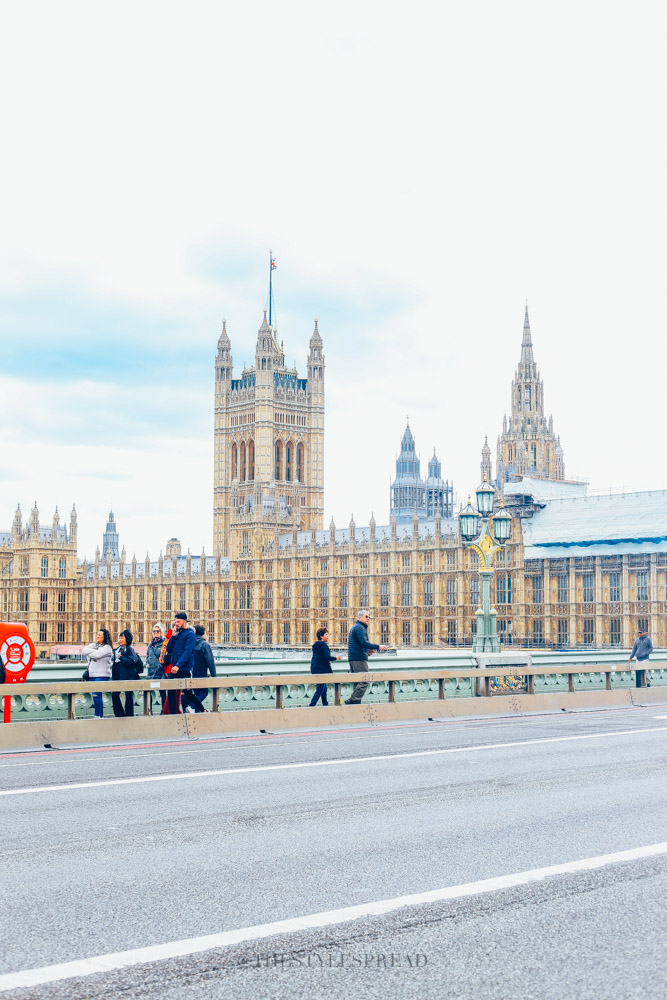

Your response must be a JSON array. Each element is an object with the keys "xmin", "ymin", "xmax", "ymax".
[{"xmin": 0, "ymin": 841, "xmax": 667, "ymax": 993}]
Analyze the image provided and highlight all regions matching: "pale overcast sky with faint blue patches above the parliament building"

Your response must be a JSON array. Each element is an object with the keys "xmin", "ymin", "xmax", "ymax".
[{"xmin": 0, "ymin": 0, "xmax": 667, "ymax": 557}]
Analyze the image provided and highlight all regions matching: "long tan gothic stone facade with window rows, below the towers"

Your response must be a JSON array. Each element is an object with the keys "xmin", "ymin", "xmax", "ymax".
[{"xmin": 0, "ymin": 498, "xmax": 667, "ymax": 656}]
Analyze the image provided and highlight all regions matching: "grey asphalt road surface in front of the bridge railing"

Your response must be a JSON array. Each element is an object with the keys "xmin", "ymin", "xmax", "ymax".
[{"xmin": 0, "ymin": 706, "xmax": 667, "ymax": 1000}]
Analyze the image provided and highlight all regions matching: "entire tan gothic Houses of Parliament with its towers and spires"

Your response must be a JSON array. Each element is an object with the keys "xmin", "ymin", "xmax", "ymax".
[{"xmin": 0, "ymin": 308, "xmax": 667, "ymax": 657}]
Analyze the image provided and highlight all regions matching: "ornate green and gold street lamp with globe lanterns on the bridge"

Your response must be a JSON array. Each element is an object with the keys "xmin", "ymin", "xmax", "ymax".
[{"xmin": 459, "ymin": 477, "xmax": 512, "ymax": 653}]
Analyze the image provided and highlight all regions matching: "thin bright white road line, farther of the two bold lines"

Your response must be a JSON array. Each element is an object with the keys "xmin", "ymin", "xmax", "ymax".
[{"xmin": 0, "ymin": 726, "xmax": 667, "ymax": 797}]
